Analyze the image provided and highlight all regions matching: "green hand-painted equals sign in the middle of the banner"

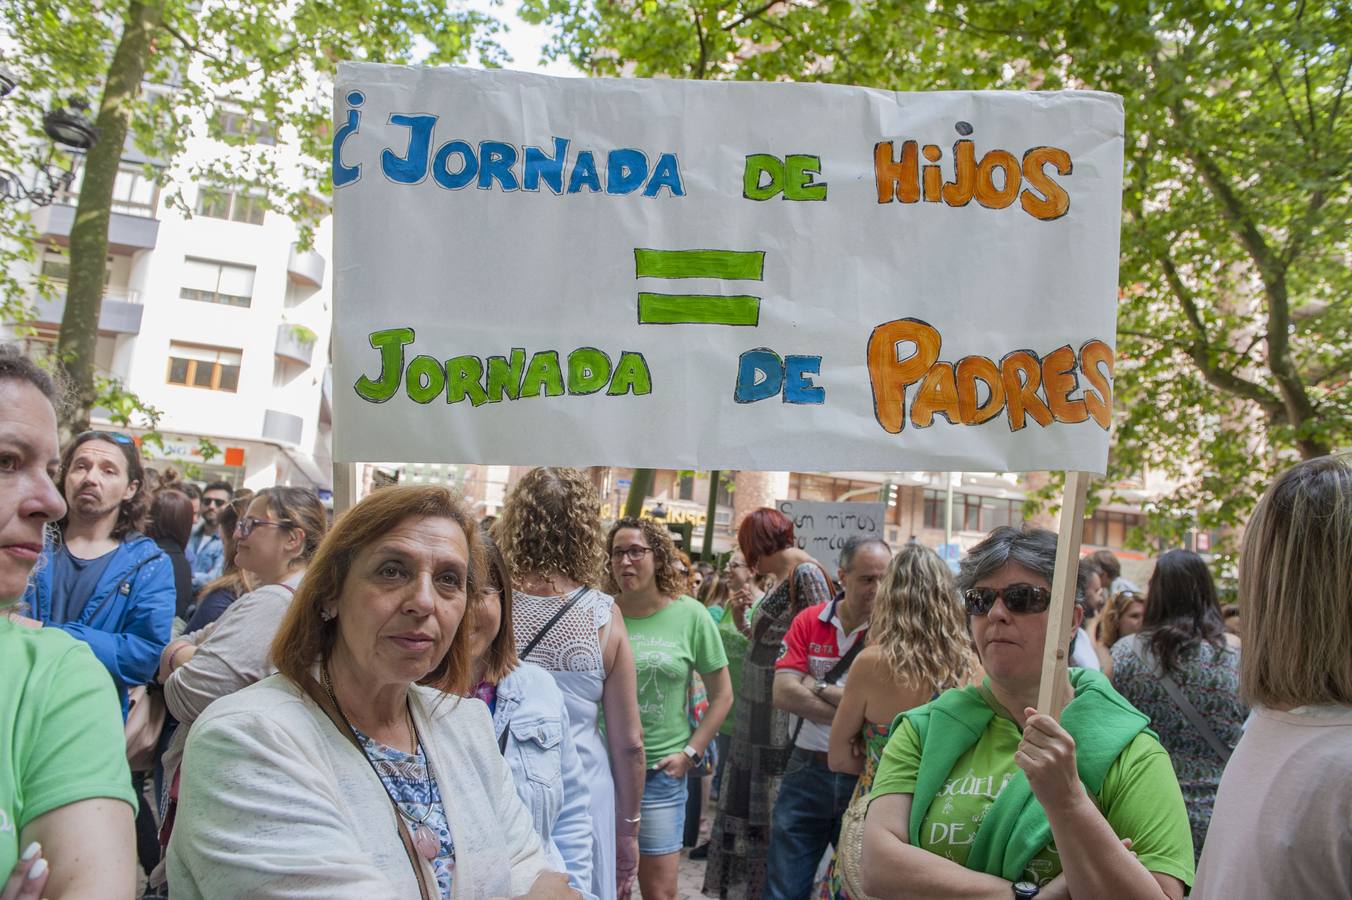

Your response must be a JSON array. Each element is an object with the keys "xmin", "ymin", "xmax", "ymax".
[{"xmin": 634, "ymin": 247, "xmax": 765, "ymax": 327}]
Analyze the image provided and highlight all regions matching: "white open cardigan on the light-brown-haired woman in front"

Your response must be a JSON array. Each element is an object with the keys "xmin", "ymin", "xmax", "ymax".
[{"xmin": 168, "ymin": 674, "xmax": 550, "ymax": 900}]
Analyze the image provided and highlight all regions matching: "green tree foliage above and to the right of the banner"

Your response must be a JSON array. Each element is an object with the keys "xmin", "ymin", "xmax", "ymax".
[{"xmin": 521, "ymin": 0, "xmax": 1352, "ymax": 556}]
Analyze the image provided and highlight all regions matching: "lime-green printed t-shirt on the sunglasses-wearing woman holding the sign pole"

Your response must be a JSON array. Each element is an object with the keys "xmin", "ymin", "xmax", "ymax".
[{"xmin": 869, "ymin": 686, "xmax": 1192, "ymax": 885}]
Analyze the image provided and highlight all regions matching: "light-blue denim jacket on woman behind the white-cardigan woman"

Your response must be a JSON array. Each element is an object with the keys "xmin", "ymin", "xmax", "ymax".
[{"xmin": 493, "ymin": 662, "xmax": 595, "ymax": 900}]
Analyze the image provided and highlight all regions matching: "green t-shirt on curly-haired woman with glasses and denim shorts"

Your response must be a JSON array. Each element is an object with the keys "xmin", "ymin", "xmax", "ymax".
[{"xmin": 625, "ymin": 595, "xmax": 727, "ymax": 766}]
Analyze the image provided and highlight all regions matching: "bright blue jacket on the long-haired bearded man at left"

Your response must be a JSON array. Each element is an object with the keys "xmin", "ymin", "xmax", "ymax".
[{"xmin": 23, "ymin": 534, "xmax": 176, "ymax": 716}]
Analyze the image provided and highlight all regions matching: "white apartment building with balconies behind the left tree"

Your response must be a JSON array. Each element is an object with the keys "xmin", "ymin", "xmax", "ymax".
[{"xmin": 14, "ymin": 109, "xmax": 333, "ymax": 491}]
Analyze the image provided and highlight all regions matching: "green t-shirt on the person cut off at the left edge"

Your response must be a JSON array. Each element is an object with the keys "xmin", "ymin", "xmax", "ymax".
[{"xmin": 0, "ymin": 618, "xmax": 137, "ymax": 880}]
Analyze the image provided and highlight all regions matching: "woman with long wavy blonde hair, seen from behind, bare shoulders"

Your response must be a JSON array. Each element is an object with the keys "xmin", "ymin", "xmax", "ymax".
[{"xmin": 822, "ymin": 543, "xmax": 973, "ymax": 900}]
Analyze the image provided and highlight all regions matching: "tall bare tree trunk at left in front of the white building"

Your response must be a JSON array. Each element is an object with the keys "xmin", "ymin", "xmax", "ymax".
[{"xmin": 57, "ymin": 0, "xmax": 164, "ymax": 438}]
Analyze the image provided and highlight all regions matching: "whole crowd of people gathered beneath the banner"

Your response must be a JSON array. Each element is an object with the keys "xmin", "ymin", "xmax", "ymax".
[{"xmin": 0, "ymin": 336, "xmax": 1352, "ymax": 900}]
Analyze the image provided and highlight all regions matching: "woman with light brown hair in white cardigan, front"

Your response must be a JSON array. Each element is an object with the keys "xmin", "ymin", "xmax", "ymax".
[{"xmin": 169, "ymin": 485, "xmax": 577, "ymax": 900}]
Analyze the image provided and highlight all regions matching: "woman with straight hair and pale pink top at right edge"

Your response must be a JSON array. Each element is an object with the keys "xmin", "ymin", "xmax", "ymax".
[{"xmin": 1192, "ymin": 453, "xmax": 1352, "ymax": 900}]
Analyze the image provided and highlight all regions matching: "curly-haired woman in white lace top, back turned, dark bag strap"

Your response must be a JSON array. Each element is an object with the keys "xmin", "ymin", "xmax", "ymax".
[{"xmin": 493, "ymin": 466, "xmax": 644, "ymax": 900}]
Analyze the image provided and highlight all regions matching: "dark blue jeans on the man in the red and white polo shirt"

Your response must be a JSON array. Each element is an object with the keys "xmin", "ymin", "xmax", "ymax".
[{"xmin": 761, "ymin": 747, "xmax": 859, "ymax": 900}]
